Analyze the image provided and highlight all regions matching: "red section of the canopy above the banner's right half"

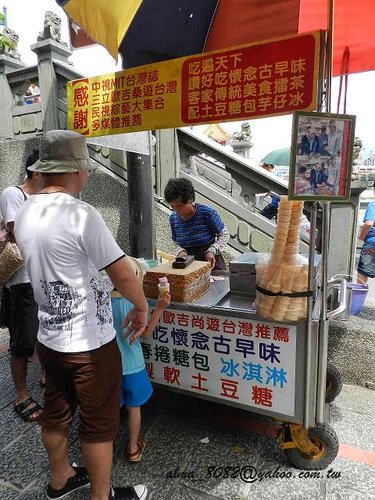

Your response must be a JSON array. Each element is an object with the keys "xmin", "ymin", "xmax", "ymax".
[{"xmin": 206, "ymin": 0, "xmax": 375, "ymax": 76}]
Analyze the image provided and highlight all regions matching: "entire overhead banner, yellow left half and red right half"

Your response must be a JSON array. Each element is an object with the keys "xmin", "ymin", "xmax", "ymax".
[{"xmin": 67, "ymin": 33, "xmax": 320, "ymax": 137}]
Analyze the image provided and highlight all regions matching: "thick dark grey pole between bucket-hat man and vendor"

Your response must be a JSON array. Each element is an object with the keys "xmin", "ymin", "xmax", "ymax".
[{"xmin": 126, "ymin": 147, "xmax": 156, "ymax": 259}]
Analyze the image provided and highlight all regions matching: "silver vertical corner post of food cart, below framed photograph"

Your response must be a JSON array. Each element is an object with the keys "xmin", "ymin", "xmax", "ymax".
[{"xmin": 303, "ymin": 202, "xmax": 317, "ymax": 429}]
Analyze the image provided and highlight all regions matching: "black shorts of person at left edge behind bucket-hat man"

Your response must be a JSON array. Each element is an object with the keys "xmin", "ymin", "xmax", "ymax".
[{"xmin": 7, "ymin": 283, "xmax": 39, "ymax": 358}]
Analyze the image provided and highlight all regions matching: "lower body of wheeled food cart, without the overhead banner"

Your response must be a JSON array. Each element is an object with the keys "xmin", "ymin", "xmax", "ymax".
[{"xmin": 142, "ymin": 198, "xmax": 347, "ymax": 469}]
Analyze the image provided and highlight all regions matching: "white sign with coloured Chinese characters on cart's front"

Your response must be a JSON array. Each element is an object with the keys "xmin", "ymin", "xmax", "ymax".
[{"xmin": 142, "ymin": 309, "xmax": 297, "ymax": 416}]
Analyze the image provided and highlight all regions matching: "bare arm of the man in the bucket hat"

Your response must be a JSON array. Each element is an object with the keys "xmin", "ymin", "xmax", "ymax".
[{"xmin": 105, "ymin": 257, "xmax": 148, "ymax": 343}]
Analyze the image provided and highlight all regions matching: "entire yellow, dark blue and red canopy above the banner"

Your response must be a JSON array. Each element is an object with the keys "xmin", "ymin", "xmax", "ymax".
[{"xmin": 56, "ymin": 0, "xmax": 375, "ymax": 76}]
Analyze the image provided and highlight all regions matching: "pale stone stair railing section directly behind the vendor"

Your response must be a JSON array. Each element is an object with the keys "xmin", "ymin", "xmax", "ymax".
[{"xmin": 156, "ymin": 129, "xmax": 308, "ymax": 253}]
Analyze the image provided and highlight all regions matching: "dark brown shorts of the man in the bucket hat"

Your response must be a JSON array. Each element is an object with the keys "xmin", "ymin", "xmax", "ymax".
[{"xmin": 37, "ymin": 339, "xmax": 122, "ymax": 443}]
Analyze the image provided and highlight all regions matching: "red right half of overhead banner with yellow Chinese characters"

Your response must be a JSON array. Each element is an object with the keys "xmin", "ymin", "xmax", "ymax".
[{"xmin": 181, "ymin": 35, "xmax": 316, "ymax": 123}]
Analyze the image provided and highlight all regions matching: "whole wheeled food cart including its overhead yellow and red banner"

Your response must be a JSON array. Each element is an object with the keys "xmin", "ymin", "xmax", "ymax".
[{"xmin": 67, "ymin": 24, "xmax": 354, "ymax": 469}]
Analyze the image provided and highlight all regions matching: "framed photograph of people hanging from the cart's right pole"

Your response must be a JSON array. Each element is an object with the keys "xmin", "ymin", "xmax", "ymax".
[{"xmin": 289, "ymin": 111, "xmax": 355, "ymax": 201}]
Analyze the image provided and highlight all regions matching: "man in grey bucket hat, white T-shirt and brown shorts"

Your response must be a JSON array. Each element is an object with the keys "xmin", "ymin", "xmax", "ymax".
[{"xmin": 15, "ymin": 130, "xmax": 148, "ymax": 500}]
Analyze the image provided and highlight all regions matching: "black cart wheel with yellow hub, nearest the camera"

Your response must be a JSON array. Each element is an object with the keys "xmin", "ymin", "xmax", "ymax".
[{"xmin": 285, "ymin": 423, "xmax": 339, "ymax": 470}]
